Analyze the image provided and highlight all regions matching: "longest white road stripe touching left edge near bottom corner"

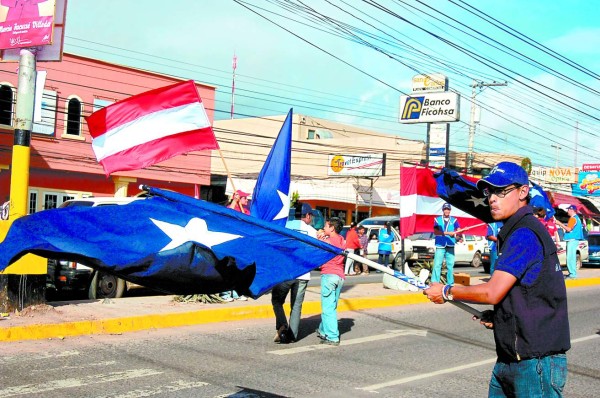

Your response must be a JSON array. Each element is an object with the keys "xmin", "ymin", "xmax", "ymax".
[{"xmin": 0, "ymin": 369, "xmax": 162, "ymax": 398}]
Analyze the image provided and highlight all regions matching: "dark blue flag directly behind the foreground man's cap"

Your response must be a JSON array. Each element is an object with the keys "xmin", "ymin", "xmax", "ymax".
[{"xmin": 434, "ymin": 168, "xmax": 495, "ymax": 224}]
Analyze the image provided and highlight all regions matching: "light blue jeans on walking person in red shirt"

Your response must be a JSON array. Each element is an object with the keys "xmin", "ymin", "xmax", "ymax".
[{"xmin": 318, "ymin": 274, "xmax": 344, "ymax": 341}]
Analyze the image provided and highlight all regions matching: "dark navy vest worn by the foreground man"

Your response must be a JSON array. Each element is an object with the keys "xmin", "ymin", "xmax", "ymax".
[{"xmin": 494, "ymin": 206, "xmax": 571, "ymax": 362}]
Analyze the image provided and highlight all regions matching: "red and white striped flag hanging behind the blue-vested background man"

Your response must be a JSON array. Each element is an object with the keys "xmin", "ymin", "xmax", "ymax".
[{"xmin": 400, "ymin": 167, "xmax": 487, "ymax": 237}]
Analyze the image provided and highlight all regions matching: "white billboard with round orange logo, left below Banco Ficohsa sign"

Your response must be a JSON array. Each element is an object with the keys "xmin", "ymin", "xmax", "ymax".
[{"xmin": 327, "ymin": 153, "xmax": 385, "ymax": 177}]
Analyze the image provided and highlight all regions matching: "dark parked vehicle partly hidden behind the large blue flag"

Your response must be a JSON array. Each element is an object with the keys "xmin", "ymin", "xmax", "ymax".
[{"xmin": 46, "ymin": 197, "xmax": 144, "ymax": 299}]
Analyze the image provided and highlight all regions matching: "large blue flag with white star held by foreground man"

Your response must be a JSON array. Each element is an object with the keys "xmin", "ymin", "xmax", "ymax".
[{"xmin": 0, "ymin": 188, "xmax": 343, "ymax": 297}]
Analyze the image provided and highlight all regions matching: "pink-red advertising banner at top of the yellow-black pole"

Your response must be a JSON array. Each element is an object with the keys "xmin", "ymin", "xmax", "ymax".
[{"xmin": 0, "ymin": 0, "xmax": 56, "ymax": 50}]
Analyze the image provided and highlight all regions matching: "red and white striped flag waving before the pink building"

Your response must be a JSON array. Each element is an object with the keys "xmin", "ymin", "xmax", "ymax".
[{"xmin": 85, "ymin": 80, "xmax": 219, "ymax": 176}]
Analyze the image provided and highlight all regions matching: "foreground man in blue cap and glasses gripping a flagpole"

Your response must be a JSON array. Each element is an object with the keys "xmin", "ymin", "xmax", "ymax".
[{"xmin": 423, "ymin": 162, "xmax": 571, "ymax": 397}]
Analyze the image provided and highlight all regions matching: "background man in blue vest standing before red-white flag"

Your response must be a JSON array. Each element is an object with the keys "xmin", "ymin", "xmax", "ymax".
[{"xmin": 431, "ymin": 203, "xmax": 460, "ymax": 285}]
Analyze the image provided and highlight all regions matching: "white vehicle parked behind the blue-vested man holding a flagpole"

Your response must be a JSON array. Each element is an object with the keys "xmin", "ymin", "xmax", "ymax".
[{"xmin": 408, "ymin": 232, "xmax": 487, "ymax": 268}]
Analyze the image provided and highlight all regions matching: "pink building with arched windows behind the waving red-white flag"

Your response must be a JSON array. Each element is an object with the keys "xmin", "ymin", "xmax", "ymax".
[{"xmin": 0, "ymin": 54, "xmax": 215, "ymax": 213}]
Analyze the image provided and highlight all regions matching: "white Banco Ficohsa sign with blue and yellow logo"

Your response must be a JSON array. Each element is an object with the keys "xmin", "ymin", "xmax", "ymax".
[{"xmin": 400, "ymin": 92, "xmax": 460, "ymax": 123}]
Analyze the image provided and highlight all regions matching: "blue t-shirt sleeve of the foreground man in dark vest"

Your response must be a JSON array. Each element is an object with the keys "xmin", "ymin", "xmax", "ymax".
[{"xmin": 496, "ymin": 228, "xmax": 544, "ymax": 285}]
